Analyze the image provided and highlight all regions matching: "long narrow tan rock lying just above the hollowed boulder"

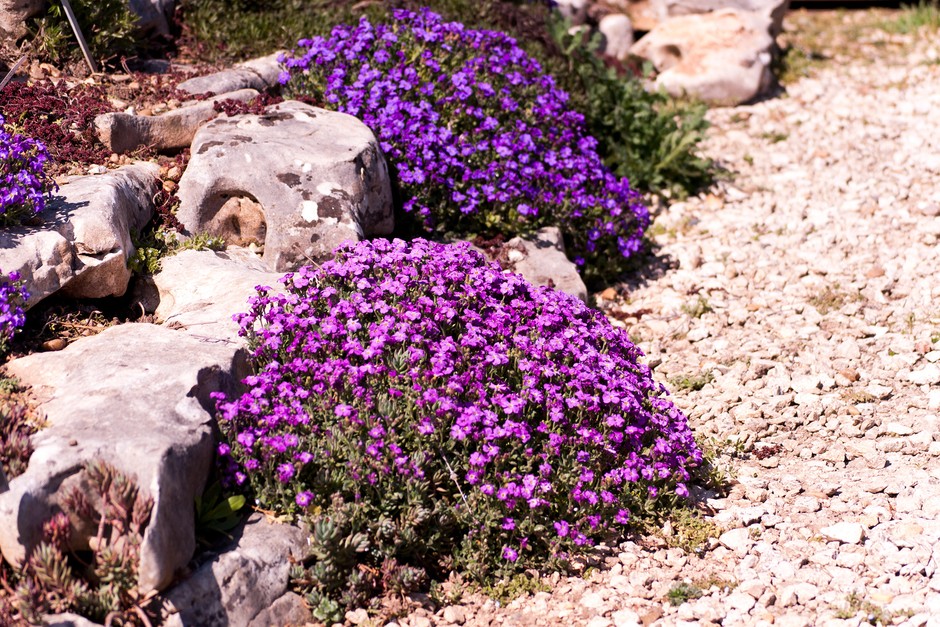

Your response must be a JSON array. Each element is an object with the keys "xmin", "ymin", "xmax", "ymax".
[{"xmin": 95, "ymin": 89, "xmax": 258, "ymax": 153}]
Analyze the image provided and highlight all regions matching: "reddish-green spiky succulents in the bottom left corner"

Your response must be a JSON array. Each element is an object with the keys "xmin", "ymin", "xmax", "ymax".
[{"xmin": 0, "ymin": 461, "xmax": 153, "ymax": 625}]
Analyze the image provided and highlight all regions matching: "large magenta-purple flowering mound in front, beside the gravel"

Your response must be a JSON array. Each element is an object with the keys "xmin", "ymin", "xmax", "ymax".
[{"xmin": 213, "ymin": 239, "xmax": 702, "ymax": 563}]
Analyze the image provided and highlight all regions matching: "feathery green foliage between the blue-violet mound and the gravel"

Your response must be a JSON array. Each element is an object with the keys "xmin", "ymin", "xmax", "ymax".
[{"xmin": 551, "ymin": 19, "xmax": 717, "ymax": 198}]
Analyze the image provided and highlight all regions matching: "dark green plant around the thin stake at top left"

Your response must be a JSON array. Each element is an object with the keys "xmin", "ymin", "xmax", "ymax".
[{"xmin": 32, "ymin": 0, "xmax": 138, "ymax": 64}]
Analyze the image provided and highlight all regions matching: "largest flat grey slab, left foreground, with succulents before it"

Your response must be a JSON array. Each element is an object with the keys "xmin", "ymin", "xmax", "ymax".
[{"xmin": 0, "ymin": 324, "xmax": 248, "ymax": 592}]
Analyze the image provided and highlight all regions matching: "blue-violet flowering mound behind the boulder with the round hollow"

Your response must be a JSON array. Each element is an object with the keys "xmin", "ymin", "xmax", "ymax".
[{"xmin": 281, "ymin": 9, "xmax": 649, "ymax": 276}]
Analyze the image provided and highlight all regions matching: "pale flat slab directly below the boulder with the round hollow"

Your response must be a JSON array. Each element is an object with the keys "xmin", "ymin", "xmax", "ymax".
[{"xmin": 153, "ymin": 247, "xmax": 282, "ymax": 345}]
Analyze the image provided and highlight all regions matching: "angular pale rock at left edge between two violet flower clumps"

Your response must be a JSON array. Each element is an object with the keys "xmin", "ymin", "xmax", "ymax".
[{"xmin": 0, "ymin": 163, "xmax": 159, "ymax": 306}]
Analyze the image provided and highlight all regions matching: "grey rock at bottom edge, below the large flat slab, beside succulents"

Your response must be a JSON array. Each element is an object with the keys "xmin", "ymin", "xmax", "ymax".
[{"xmin": 165, "ymin": 514, "xmax": 309, "ymax": 627}]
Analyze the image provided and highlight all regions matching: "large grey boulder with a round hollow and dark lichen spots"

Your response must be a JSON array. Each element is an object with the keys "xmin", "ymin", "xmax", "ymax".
[{"xmin": 177, "ymin": 101, "xmax": 394, "ymax": 272}]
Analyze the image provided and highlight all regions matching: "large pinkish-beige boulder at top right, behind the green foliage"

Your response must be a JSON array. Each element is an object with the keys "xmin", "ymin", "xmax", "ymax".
[{"xmin": 631, "ymin": 9, "xmax": 774, "ymax": 105}]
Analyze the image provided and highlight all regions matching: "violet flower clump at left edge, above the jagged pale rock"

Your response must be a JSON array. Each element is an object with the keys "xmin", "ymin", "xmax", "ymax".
[{"xmin": 0, "ymin": 115, "xmax": 52, "ymax": 224}]
